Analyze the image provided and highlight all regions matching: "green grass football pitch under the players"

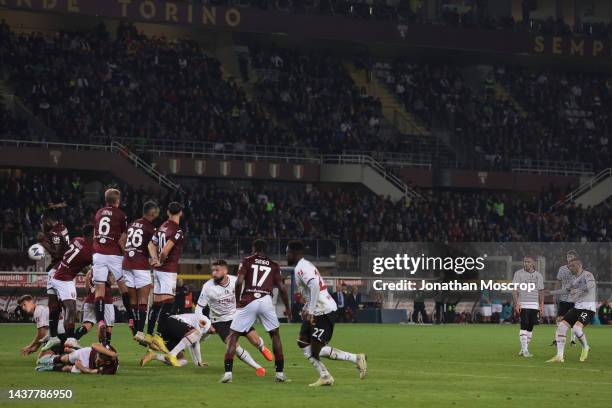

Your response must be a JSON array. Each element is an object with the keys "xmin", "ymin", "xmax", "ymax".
[{"xmin": 0, "ymin": 324, "xmax": 612, "ymax": 408}]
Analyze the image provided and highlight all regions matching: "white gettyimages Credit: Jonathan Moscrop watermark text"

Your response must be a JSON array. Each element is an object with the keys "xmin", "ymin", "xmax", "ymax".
[{"xmin": 372, "ymin": 254, "xmax": 536, "ymax": 292}]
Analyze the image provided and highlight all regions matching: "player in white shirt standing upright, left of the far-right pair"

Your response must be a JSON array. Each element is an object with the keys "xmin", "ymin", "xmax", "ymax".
[{"xmin": 512, "ymin": 256, "xmax": 544, "ymax": 357}]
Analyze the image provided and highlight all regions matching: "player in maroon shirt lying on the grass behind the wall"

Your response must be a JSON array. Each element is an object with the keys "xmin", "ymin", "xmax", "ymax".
[{"xmin": 36, "ymin": 343, "xmax": 119, "ymax": 375}]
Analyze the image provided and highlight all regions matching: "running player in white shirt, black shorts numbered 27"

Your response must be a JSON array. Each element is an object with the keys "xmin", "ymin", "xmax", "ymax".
[{"xmin": 287, "ymin": 241, "xmax": 368, "ymax": 387}]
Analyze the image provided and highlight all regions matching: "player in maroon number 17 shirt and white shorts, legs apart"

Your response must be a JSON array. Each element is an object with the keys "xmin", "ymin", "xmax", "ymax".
[{"xmin": 221, "ymin": 239, "xmax": 291, "ymax": 383}]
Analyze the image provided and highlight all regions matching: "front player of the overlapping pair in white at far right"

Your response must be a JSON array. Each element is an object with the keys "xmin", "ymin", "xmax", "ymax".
[{"xmin": 548, "ymin": 258, "xmax": 597, "ymax": 363}]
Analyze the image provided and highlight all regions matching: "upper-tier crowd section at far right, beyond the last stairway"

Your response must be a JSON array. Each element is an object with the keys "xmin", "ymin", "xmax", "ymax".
[{"xmin": 496, "ymin": 68, "xmax": 612, "ymax": 169}]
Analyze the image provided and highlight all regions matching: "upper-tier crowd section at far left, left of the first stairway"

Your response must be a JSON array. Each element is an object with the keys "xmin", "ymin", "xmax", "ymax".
[{"xmin": 0, "ymin": 20, "xmax": 278, "ymax": 144}]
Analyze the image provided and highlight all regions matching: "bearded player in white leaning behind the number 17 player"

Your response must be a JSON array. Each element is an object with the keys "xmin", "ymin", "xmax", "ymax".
[{"xmin": 196, "ymin": 259, "xmax": 273, "ymax": 377}]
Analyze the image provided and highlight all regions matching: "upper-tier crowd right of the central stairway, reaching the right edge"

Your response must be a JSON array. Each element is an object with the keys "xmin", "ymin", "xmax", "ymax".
[{"xmin": 372, "ymin": 59, "xmax": 612, "ymax": 169}]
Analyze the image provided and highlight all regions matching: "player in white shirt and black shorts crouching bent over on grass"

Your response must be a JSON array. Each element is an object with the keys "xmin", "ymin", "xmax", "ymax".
[{"xmin": 140, "ymin": 313, "xmax": 215, "ymax": 367}]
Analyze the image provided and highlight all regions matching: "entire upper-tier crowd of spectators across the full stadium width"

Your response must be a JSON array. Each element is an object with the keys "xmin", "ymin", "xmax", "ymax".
[{"xmin": 0, "ymin": 20, "xmax": 612, "ymax": 169}]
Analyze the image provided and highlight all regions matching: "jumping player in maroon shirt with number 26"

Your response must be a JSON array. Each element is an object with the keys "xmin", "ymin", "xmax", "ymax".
[{"xmin": 123, "ymin": 201, "xmax": 159, "ymax": 344}]
